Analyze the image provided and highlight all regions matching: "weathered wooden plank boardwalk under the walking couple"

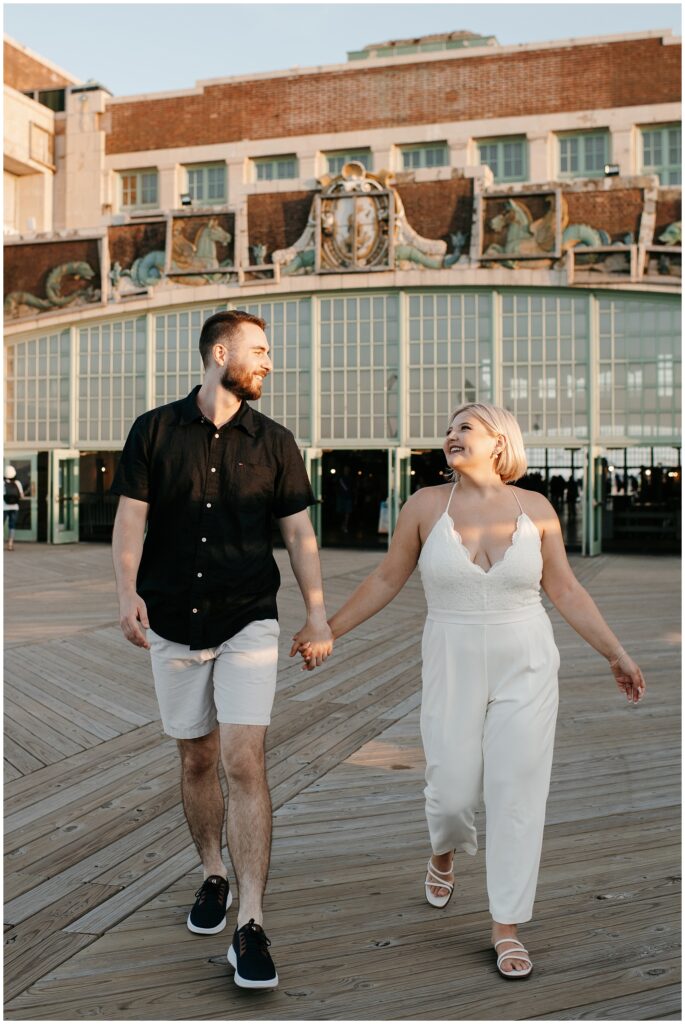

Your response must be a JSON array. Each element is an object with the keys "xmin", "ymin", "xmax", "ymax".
[{"xmin": 5, "ymin": 545, "xmax": 680, "ymax": 1020}]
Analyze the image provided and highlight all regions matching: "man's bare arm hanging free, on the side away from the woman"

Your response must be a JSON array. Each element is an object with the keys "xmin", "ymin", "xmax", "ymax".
[{"xmin": 112, "ymin": 495, "xmax": 149, "ymax": 648}]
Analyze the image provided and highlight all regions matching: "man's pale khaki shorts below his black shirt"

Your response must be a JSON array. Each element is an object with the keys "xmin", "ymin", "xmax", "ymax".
[{"xmin": 147, "ymin": 618, "xmax": 281, "ymax": 739}]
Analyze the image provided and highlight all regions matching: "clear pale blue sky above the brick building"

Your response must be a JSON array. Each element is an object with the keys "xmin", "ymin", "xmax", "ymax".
[{"xmin": 3, "ymin": 0, "xmax": 681, "ymax": 96}]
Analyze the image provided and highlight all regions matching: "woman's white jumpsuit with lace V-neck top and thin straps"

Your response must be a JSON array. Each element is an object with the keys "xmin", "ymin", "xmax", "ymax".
[{"xmin": 419, "ymin": 487, "xmax": 559, "ymax": 924}]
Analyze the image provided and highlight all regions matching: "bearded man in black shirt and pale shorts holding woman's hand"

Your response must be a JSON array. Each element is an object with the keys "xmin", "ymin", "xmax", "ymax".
[{"xmin": 112, "ymin": 310, "xmax": 333, "ymax": 988}]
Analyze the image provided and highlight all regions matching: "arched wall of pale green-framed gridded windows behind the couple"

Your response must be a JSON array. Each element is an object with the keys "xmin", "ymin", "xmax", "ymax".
[{"xmin": 5, "ymin": 288, "xmax": 681, "ymax": 550}]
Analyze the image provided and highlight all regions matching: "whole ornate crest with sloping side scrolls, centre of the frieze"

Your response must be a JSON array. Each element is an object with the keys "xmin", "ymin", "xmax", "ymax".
[{"xmin": 271, "ymin": 161, "xmax": 466, "ymax": 275}]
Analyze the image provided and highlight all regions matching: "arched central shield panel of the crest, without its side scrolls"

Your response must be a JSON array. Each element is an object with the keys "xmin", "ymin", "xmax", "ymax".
[{"xmin": 316, "ymin": 161, "xmax": 394, "ymax": 273}]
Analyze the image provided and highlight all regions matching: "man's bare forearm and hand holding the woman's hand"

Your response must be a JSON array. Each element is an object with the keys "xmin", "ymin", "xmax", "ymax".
[{"xmin": 279, "ymin": 509, "xmax": 333, "ymax": 669}]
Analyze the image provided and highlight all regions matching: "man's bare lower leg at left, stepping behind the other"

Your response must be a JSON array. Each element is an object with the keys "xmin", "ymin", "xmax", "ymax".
[{"xmin": 176, "ymin": 726, "xmax": 228, "ymax": 879}]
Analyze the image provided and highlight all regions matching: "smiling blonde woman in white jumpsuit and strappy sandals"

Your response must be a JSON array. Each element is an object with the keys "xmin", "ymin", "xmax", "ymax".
[{"xmin": 292, "ymin": 403, "xmax": 645, "ymax": 979}]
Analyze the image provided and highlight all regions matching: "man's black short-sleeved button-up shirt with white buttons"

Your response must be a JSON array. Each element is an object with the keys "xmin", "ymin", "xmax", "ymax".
[{"xmin": 112, "ymin": 387, "xmax": 316, "ymax": 650}]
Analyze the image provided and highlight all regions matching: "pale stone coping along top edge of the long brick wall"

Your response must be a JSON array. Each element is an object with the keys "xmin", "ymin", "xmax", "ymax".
[{"xmin": 108, "ymin": 29, "xmax": 682, "ymax": 104}]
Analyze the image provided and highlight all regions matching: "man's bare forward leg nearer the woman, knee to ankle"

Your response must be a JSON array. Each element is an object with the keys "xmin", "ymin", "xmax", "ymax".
[{"xmin": 220, "ymin": 725, "xmax": 271, "ymax": 928}]
